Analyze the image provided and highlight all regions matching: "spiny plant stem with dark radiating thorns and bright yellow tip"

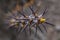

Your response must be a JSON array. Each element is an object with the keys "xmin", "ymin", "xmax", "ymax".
[{"xmin": 5, "ymin": 0, "xmax": 54, "ymax": 33}]
